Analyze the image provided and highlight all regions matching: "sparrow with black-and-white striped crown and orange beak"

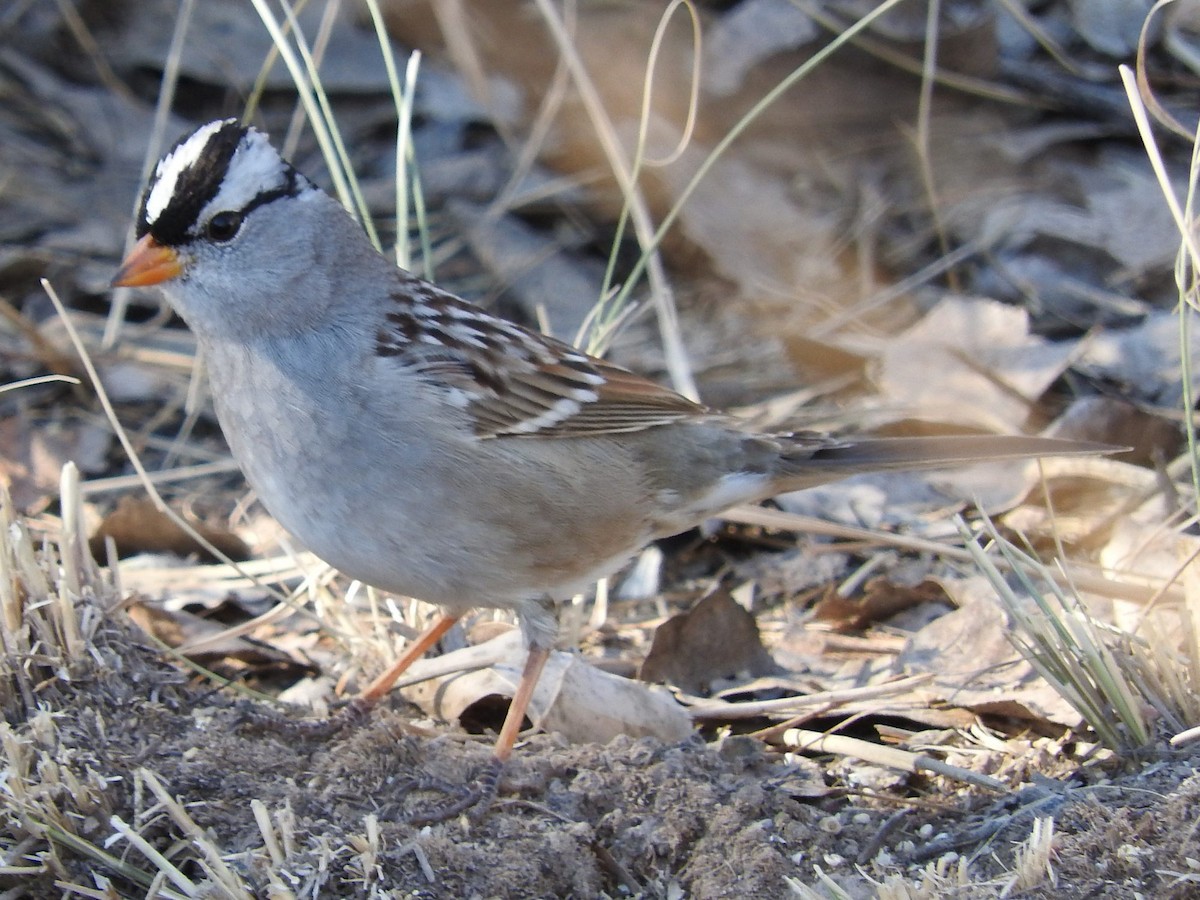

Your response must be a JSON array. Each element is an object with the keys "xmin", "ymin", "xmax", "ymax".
[{"xmin": 113, "ymin": 119, "xmax": 1098, "ymax": 816}]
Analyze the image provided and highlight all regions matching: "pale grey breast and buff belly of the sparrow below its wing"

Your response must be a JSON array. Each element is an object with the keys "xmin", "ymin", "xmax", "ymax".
[{"xmin": 215, "ymin": 348, "xmax": 654, "ymax": 610}]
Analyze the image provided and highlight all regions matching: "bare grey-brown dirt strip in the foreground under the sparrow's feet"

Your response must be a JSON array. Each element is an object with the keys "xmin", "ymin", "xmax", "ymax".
[{"xmin": 0, "ymin": 595, "xmax": 1200, "ymax": 898}]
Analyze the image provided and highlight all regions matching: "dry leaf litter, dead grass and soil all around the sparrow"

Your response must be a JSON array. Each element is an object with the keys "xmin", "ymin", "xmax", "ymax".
[{"xmin": 0, "ymin": 0, "xmax": 1200, "ymax": 898}]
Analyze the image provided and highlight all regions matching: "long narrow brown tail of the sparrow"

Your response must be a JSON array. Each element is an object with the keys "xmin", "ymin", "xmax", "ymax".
[{"xmin": 776, "ymin": 434, "xmax": 1124, "ymax": 491}]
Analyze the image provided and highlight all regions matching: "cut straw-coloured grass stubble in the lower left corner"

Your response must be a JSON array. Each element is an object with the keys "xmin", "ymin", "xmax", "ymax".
[{"xmin": 0, "ymin": 472, "xmax": 304, "ymax": 900}]
